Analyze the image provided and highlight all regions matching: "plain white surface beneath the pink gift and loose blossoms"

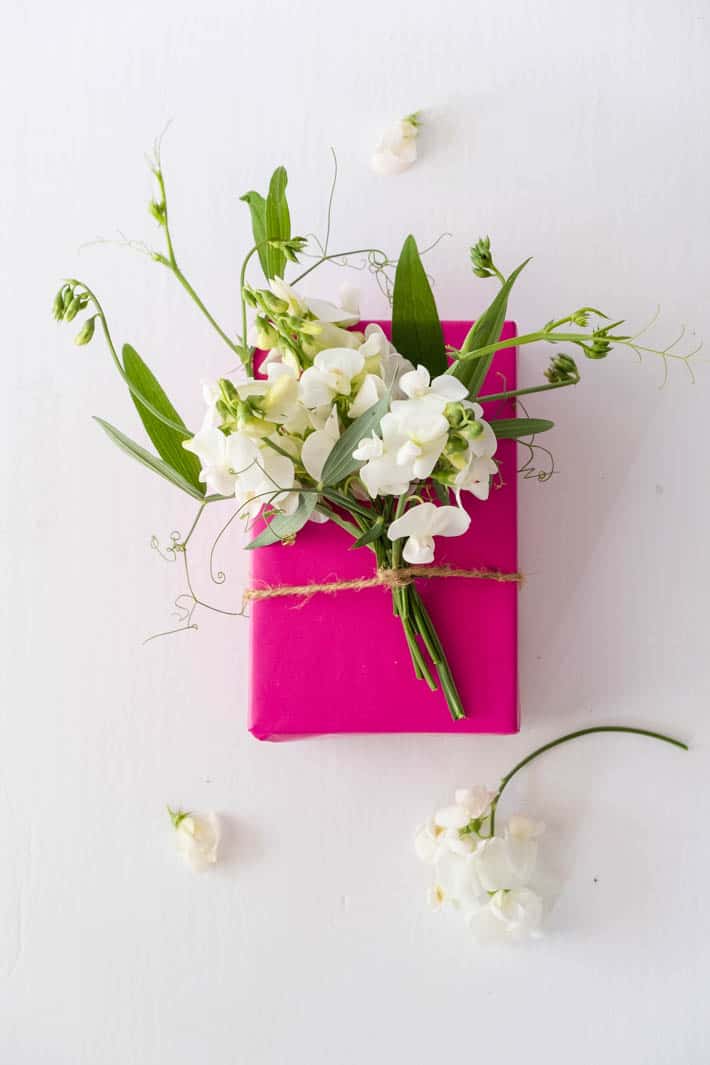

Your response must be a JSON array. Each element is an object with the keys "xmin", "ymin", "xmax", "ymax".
[{"xmin": 0, "ymin": 0, "xmax": 710, "ymax": 1065}]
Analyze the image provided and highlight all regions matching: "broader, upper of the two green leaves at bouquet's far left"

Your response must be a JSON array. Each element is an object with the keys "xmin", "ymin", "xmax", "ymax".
[{"xmin": 121, "ymin": 344, "xmax": 204, "ymax": 494}]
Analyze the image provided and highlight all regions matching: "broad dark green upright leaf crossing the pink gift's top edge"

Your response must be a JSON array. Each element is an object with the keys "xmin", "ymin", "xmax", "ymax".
[{"xmin": 392, "ymin": 236, "xmax": 447, "ymax": 377}]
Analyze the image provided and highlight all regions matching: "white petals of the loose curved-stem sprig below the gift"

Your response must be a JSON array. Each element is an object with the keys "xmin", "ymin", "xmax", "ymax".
[{"xmin": 415, "ymin": 786, "xmax": 544, "ymax": 943}]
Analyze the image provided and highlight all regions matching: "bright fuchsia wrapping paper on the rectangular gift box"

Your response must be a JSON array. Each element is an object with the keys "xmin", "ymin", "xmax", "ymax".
[{"xmin": 249, "ymin": 322, "xmax": 518, "ymax": 740}]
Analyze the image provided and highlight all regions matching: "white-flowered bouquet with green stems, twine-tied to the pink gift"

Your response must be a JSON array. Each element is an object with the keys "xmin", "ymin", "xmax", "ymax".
[{"xmin": 53, "ymin": 143, "xmax": 694, "ymax": 720}]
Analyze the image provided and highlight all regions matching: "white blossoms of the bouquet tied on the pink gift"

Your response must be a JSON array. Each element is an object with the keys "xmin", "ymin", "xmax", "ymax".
[{"xmin": 184, "ymin": 279, "xmax": 497, "ymax": 563}]
